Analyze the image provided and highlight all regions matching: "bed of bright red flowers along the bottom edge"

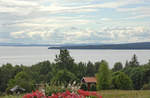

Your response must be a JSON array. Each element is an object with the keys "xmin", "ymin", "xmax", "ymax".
[{"xmin": 23, "ymin": 89, "xmax": 102, "ymax": 98}]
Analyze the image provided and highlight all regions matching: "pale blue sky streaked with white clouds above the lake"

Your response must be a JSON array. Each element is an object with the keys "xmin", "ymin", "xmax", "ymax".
[{"xmin": 0, "ymin": 0, "xmax": 150, "ymax": 44}]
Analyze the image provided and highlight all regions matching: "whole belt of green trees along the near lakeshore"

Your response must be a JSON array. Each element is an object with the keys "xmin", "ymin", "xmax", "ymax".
[{"xmin": 0, "ymin": 49, "xmax": 150, "ymax": 93}]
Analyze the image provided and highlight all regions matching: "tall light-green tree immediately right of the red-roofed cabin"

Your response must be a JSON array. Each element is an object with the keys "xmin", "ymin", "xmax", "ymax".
[{"xmin": 96, "ymin": 60, "xmax": 111, "ymax": 90}]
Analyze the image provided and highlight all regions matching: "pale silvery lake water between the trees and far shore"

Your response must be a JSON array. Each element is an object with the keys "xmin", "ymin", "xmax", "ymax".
[{"xmin": 0, "ymin": 46, "xmax": 150, "ymax": 68}]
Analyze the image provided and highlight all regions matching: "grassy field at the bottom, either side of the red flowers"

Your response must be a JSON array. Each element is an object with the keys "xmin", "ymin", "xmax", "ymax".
[{"xmin": 0, "ymin": 90, "xmax": 150, "ymax": 98}]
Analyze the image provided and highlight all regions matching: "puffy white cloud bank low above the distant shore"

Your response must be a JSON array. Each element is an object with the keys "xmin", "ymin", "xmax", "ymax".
[{"xmin": 9, "ymin": 27, "xmax": 150, "ymax": 44}]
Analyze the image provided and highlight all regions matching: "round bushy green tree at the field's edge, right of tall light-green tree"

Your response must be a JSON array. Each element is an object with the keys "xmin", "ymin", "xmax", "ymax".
[{"xmin": 112, "ymin": 72, "xmax": 133, "ymax": 90}]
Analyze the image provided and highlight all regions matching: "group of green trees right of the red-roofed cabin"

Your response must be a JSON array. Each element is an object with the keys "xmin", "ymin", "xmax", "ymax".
[{"xmin": 97, "ymin": 55, "xmax": 150, "ymax": 90}]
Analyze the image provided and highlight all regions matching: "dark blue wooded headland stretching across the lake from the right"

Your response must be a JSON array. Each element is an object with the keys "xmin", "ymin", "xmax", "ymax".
[{"xmin": 48, "ymin": 42, "xmax": 150, "ymax": 50}]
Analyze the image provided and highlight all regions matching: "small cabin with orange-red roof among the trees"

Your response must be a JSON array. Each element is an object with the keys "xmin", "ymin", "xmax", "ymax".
[{"xmin": 81, "ymin": 77, "xmax": 97, "ymax": 90}]
